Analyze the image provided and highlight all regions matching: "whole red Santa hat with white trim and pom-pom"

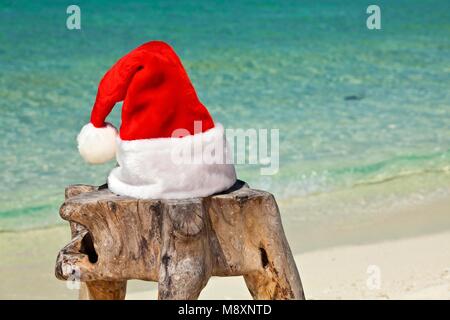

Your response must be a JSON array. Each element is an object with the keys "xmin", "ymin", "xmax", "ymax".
[{"xmin": 77, "ymin": 41, "xmax": 236, "ymax": 198}]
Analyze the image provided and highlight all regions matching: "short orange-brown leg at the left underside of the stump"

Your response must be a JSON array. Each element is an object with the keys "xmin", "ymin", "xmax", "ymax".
[{"xmin": 79, "ymin": 281, "xmax": 127, "ymax": 300}]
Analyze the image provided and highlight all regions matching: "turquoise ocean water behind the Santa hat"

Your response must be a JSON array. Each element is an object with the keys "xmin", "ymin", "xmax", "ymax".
[{"xmin": 0, "ymin": 0, "xmax": 450, "ymax": 231}]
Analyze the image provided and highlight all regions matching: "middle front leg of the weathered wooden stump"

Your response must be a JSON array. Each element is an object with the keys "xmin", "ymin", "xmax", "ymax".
[{"xmin": 158, "ymin": 201, "xmax": 211, "ymax": 300}]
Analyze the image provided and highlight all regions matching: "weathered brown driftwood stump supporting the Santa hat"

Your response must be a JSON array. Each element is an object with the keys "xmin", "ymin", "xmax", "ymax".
[{"xmin": 56, "ymin": 181, "xmax": 304, "ymax": 299}]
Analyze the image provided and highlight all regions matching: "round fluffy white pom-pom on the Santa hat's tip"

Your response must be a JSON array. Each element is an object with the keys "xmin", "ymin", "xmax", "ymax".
[{"xmin": 77, "ymin": 123, "xmax": 117, "ymax": 164}]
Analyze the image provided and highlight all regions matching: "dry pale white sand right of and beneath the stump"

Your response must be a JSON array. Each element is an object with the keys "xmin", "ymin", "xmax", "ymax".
[{"xmin": 127, "ymin": 232, "xmax": 450, "ymax": 299}]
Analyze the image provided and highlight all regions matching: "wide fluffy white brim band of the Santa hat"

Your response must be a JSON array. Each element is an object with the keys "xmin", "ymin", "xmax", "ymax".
[{"xmin": 108, "ymin": 124, "xmax": 236, "ymax": 199}]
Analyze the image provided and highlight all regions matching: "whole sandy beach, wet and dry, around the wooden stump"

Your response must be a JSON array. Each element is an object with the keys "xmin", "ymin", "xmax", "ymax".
[{"xmin": 0, "ymin": 198, "xmax": 450, "ymax": 299}]
